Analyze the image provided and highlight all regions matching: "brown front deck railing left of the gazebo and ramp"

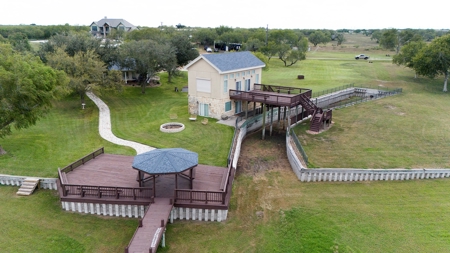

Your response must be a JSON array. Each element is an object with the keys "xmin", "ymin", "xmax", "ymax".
[{"xmin": 62, "ymin": 184, "xmax": 153, "ymax": 200}]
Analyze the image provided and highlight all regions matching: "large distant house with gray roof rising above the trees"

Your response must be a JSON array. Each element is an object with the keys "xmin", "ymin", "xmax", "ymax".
[{"xmin": 90, "ymin": 17, "xmax": 139, "ymax": 37}]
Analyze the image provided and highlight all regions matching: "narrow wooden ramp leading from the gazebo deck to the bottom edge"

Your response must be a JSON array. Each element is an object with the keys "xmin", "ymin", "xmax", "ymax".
[{"xmin": 125, "ymin": 198, "xmax": 173, "ymax": 253}]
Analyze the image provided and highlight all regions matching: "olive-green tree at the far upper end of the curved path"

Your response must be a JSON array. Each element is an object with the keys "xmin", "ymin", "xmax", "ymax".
[{"xmin": 47, "ymin": 47, "xmax": 121, "ymax": 103}]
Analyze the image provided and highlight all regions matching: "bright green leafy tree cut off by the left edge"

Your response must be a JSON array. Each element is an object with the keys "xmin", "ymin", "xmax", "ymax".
[{"xmin": 0, "ymin": 44, "xmax": 67, "ymax": 151}]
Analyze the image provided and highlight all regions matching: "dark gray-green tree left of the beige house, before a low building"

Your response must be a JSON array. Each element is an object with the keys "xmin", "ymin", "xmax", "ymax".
[{"xmin": 119, "ymin": 40, "xmax": 162, "ymax": 93}]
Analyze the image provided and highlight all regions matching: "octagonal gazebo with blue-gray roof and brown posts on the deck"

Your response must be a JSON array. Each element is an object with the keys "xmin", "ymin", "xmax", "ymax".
[{"xmin": 132, "ymin": 148, "xmax": 198, "ymax": 197}]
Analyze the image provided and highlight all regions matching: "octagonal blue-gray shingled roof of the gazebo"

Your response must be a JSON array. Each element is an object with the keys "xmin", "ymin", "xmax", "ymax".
[{"xmin": 132, "ymin": 148, "xmax": 198, "ymax": 175}]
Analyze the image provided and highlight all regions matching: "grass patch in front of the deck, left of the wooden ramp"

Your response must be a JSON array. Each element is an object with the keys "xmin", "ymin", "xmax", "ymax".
[{"xmin": 0, "ymin": 186, "xmax": 138, "ymax": 253}]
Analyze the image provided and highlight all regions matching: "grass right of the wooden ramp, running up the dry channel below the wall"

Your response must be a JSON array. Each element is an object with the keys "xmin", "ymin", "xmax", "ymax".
[{"xmin": 160, "ymin": 133, "xmax": 450, "ymax": 253}]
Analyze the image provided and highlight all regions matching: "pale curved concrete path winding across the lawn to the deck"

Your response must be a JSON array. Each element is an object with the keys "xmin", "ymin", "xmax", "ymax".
[{"xmin": 86, "ymin": 91, "xmax": 155, "ymax": 154}]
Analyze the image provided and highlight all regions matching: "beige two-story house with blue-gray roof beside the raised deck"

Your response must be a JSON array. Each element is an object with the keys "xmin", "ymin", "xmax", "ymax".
[{"xmin": 185, "ymin": 51, "xmax": 266, "ymax": 119}]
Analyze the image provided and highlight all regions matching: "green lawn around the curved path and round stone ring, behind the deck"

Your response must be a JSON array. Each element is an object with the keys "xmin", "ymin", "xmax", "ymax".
[{"xmin": 0, "ymin": 71, "xmax": 233, "ymax": 177}]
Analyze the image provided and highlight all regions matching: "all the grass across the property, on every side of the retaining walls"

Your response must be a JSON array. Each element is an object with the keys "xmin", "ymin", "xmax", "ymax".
[{"xmin": 0, "ymin": 35, "xmax": 450, "ymax": 252}]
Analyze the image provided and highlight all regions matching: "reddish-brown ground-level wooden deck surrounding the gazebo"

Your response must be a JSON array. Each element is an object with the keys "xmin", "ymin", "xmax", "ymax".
[{"xmin": 60, "ymin": 154, "xmax": 230, "ymax": 209}]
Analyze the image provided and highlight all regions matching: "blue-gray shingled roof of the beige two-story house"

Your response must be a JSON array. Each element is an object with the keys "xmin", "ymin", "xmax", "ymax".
[{"xmin": 186, "ymin": 51, "xmax": 266, "ymax": 73}]
